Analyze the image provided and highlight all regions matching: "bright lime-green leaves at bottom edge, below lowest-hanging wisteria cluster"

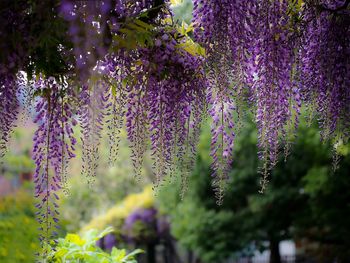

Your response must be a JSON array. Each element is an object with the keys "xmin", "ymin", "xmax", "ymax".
[{"xmin": 47, "ymin": 228, "xmax": 143, "ymax": 263}]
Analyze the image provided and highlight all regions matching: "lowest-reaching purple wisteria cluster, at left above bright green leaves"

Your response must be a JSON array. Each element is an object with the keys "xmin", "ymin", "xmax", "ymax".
[{"xmin": 33, "ymin": 77, "xmax": 77, "ymax": 256}]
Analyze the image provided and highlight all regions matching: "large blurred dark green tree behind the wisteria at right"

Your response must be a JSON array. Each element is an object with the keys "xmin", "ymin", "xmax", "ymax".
[{"xmin": 157, "ymin": 118, "xmax": 350, "ymax": 262}]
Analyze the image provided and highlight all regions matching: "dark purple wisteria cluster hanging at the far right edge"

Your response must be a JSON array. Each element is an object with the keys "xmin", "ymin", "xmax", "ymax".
[{"xmin": 300, "ymin": 3, "xmax": 350, "ymax": 145}]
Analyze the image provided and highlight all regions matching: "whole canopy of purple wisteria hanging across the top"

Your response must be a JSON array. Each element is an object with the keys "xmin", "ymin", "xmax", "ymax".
[{"xmin": 0, "ymin": 0, "xmax": 350, "ymax": 254}]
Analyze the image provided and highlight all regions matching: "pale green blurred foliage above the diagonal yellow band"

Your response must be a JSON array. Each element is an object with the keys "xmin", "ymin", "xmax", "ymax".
[{"xmin": 60, "ymin": 131, "xmax": 151, "ymax": 232}]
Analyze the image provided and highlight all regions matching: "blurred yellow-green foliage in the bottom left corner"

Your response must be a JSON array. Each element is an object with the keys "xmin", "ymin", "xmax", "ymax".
[{"xmin": 0, "ymin": 190, "xmax": 39, "ymax": 263}]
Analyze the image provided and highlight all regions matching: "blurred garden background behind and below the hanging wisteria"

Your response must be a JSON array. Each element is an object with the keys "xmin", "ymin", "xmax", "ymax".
[{"xmin": 0, "ymin": 0, "xmax": 350, "ymax": 263}]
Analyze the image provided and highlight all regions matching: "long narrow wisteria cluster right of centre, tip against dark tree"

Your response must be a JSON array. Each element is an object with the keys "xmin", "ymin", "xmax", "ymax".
[{"xmin": 193, "ymin": 0, "xmax": 240, "ymax": 203}]
